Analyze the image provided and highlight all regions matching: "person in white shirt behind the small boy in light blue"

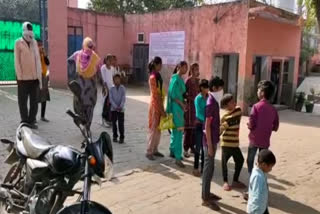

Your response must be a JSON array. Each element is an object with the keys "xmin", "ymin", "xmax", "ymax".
[{"xmin": 101, "ymin": 54, "xmax": 115, "ymax": 127}]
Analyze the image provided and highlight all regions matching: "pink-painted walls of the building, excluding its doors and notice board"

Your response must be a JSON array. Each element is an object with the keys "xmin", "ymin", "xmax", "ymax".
[{"xmin": 49, "ymin": 2, "xmax": 300, "ymax": 106}]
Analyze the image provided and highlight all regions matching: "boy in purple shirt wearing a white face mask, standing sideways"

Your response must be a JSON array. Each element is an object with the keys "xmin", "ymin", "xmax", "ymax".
[{"xmin": 202, "ymin": 77, "xmax": 222, "ymax": 211}]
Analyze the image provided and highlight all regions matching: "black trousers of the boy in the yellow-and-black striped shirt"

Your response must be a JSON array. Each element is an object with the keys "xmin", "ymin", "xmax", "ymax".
[{"xmin": 221, "ymin": 146, "xmax": 244, "ymax": 182}]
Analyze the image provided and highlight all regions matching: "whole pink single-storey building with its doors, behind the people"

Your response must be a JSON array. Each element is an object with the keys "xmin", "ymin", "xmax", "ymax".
[{"xmin": 49, "ymin": 0, "xmax": 301, "ymax": 110}]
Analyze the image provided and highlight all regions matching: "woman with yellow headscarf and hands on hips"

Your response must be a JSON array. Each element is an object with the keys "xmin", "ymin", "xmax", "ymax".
[{"xmin": 68, "ymin": 37, "xmax": 100, "ymax": 128}]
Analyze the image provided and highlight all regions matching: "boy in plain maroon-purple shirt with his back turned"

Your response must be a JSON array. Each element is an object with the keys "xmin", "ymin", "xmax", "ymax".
[{"xmin": 247, "ymin": 80, "xmax": 279, "ymax": 174}]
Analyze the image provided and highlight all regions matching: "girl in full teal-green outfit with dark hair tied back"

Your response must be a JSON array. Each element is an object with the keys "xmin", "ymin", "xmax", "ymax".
[{"xmin": 167, "ymin": 61, "xmax": 188, "ymax": 168}]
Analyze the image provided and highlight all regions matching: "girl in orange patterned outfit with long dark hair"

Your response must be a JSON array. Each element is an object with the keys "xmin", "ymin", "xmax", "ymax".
[{"xmin": 146, "ymin": 56, "xmax": 166, "ymax": 160}]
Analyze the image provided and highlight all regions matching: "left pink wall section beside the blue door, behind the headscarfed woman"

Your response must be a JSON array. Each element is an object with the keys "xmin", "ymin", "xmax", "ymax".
[{"xmin": 68, "ymin": 8, "xmax": 128, "ymax": 64}]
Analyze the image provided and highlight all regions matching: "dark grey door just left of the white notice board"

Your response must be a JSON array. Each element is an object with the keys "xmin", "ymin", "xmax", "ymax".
[{"xmin": 132, "ymin": 44, "xmax": 149, "ymax": 83}]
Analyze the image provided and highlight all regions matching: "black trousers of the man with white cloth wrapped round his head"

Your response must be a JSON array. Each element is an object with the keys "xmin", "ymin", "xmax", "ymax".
[{"xmin": 17, "ymin": 80, "xmax": 39, "ymax": 124}]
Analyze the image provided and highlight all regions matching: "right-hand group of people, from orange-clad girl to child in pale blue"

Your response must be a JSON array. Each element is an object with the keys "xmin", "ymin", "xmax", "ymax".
[{"xmin": 146, "ymin": 57, "xmax": 279, "ymax": 214}]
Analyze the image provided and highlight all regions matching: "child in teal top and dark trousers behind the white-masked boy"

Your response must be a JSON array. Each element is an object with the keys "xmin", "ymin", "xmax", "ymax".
[{"xmin": 193, "ymin": 79, "xmax": 209, "ymax": 177}]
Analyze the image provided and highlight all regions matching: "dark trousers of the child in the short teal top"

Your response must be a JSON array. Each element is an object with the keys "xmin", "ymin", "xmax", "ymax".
[{"xmin": 194, "ymin": 123, "xmax": 204, "ymax": 172}]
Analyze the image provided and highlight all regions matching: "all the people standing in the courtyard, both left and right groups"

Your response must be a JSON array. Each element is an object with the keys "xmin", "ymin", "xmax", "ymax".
[{"xmin": 15, "ymin": 22, "xmax": 279, "ymax": 214}]
